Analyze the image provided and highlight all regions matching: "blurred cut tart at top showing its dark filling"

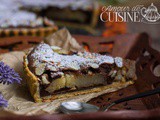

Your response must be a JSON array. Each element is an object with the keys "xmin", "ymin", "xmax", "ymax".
[{"xmin": 21, "ymin": 0, "xmax": 100, "ymax": 32}]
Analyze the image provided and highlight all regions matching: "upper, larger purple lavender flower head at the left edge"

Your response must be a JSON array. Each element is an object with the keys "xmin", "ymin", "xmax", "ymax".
[{"xmin": 0, "ymin": 62, "xmax": 22, "ymax": 84}]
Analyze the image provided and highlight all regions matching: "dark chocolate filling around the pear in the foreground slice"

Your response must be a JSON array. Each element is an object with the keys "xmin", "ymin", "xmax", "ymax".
[{"xmin": 40, "ymin": 64, "xmax": 114, "ymax": 97}]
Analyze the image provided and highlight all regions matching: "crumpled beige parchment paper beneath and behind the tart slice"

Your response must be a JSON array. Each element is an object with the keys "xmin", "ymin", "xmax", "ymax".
[{"xmin": 0, "ymin": 29, "xmax": 124, "ymax": 116}]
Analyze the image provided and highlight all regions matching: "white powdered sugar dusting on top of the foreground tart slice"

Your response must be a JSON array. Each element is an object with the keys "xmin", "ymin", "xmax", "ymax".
[{"xmin": 30, "ymin": 43, "xmax": 123, "ymax": 71}]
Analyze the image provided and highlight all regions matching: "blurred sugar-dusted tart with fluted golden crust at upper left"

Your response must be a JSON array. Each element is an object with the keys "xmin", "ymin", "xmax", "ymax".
[{"xmin": 0, "ymin": 1, "xmax": 58, "ymax": 37}]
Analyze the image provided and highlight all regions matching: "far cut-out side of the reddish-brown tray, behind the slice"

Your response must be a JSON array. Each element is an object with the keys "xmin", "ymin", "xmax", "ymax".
[{"xmin": 0, "ymin": 34, "xmax": 138, "ymax": 58}]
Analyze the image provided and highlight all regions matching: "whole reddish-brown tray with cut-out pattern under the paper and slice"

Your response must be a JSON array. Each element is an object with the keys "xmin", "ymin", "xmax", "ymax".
[{"xmin": 0, "ymin": 33, "xmax": 160, "ymax": 120}]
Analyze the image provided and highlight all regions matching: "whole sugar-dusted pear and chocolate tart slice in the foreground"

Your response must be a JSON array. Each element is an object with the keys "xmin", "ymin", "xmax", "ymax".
[{"xmin": 24, "ymin": 43, "xmax": 136, "ymax": 102}]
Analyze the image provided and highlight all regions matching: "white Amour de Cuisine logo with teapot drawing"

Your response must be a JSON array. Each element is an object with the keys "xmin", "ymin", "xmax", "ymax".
[{"xmin": 100, "ymin": 3, "xmax": 160, "ymax": 24}]
